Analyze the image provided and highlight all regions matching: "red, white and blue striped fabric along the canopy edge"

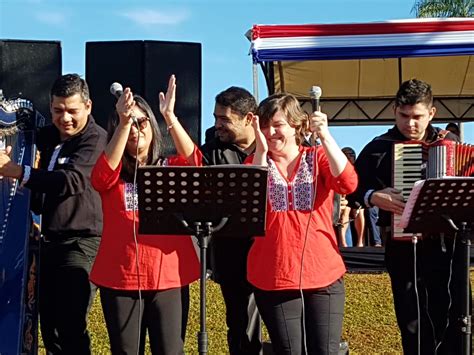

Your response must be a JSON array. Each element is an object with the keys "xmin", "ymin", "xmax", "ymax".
[{"xmin": 251, "ymin": 18, "xmax": 474, "ymax": 62}]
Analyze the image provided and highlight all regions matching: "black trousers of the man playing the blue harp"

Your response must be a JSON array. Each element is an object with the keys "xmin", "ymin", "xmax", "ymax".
[{"xmin": 39, "ymin": 237, "xmax": 100, "ymax": 355}]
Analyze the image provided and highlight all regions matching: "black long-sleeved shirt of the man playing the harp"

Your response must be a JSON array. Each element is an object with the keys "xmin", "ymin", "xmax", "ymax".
[{"xmin": 25, "ymin": 116, "xmax": 107, "ymax": 238}]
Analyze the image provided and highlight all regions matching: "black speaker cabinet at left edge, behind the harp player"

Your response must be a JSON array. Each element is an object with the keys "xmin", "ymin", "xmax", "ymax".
[{"xmin": 0, "ymin": 40, "xmax": 62, "ymax": 121}]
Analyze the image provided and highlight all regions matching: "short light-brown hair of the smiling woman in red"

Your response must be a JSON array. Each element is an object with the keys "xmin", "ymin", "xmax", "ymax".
[{"xmin": 257, "ymin": 93, "xmax": 309, "ymax": 145}]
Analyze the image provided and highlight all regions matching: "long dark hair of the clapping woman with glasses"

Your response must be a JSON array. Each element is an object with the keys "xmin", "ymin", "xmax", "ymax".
[{"xmin": 107, "ymin": 95, "xmax": 163, "ymax": 182}]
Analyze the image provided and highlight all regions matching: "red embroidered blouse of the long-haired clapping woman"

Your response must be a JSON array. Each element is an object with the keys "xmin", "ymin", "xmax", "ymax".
[{"xmin": 90, "ymin": 149, "xmax": 200, "ymax": 290}]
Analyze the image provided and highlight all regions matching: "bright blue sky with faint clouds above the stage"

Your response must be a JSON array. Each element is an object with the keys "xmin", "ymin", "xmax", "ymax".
[{"xmin": 0, "ymin": 0, "xmax": 474, "ymax": 152}]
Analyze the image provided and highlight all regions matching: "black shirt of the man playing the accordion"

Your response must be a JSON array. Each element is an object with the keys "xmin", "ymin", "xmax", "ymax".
[{"xmin": 348, "ymin": 125, "xmax": 459, "ymax": 226}]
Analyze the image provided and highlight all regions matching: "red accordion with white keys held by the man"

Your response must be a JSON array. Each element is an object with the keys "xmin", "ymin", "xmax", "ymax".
[{"xmin": 392, "ymin": 139, "xmax": 474, "ymax": 240}]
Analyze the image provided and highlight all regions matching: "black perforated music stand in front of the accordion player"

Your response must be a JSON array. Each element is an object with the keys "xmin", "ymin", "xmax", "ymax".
[{"xmin": 405, "ymin": 177, "xmax": 474, "ymax": 355}]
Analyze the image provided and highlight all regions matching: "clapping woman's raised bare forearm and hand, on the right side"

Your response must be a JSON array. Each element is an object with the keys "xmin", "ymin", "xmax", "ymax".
[{"xmin": 159, "ymin": 75, "xmax": 194, "ymax": 165}]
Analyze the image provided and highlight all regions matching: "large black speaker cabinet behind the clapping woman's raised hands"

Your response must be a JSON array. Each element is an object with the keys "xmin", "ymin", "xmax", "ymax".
[{"xmin": 86, "ymin": 41, "xmax": 201, "ymax": 155}]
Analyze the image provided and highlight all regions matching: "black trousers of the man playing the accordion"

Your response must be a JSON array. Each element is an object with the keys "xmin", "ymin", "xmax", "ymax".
[{"xmin": 386, "ymin": 237, "xmax": 472, "ymax": 355}]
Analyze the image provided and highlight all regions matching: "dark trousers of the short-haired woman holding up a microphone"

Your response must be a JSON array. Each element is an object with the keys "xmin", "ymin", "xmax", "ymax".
[{"xmin": 255, "ymin": 278, "xmax": 345, "ymax": 355}]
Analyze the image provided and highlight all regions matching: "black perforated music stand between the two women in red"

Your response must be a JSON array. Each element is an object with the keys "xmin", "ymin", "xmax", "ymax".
[{"xmin": 138, "ymin": 165, "xmax": 267, "ymax": 354}]
